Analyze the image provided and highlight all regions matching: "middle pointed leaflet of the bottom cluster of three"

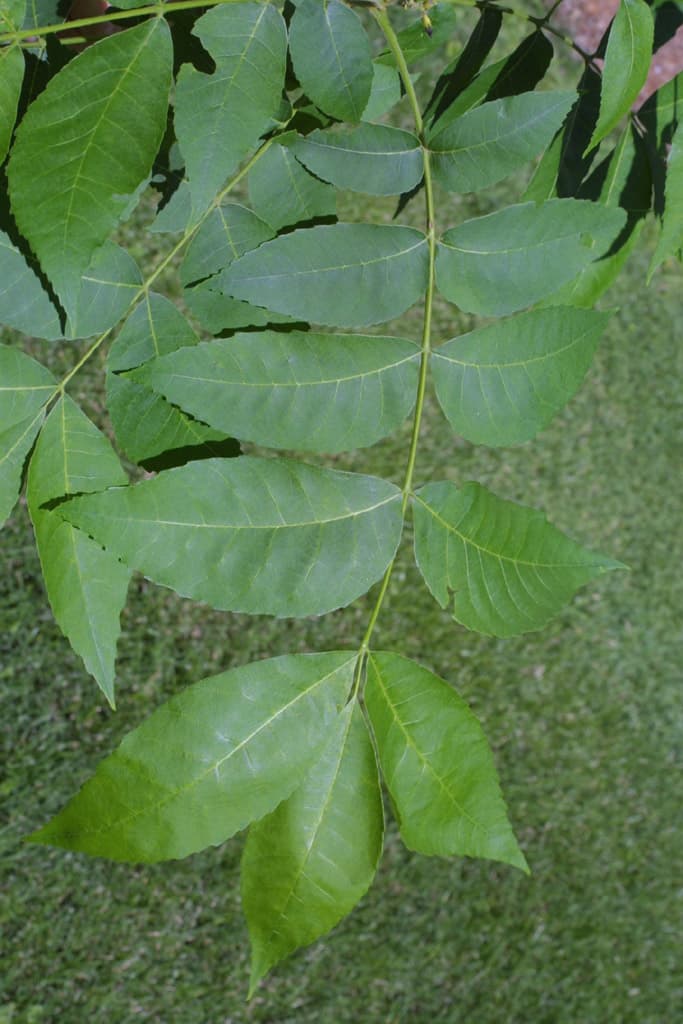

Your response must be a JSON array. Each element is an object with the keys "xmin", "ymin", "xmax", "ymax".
[{"xmin": 242, "ymin": 700, "xmax": 384, "ymax": 996}]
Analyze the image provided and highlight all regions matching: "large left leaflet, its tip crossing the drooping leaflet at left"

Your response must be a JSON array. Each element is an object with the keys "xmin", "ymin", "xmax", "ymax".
[{"xmin": 58, "ymin": 456, "xmax": 401, "ymax": 616}]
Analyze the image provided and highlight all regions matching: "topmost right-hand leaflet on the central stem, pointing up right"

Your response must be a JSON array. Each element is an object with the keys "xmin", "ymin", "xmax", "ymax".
[{"xmin": 427, "ymin": 92, "xmax": 577, "ymax": 193}]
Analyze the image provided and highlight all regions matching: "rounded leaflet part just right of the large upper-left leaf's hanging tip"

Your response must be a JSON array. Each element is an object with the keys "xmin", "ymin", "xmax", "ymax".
[{"xmin": 66, "ymin": 242, "xmax": 142, "ymax": 338}]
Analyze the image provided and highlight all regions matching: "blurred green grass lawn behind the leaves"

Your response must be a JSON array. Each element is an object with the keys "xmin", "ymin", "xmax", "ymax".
[{"xmin": 0, "ymin": 6, "xmax": 683, "ymax": 1024}]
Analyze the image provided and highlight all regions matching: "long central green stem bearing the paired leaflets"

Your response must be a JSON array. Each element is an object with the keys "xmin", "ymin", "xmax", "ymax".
[{"xmin": 352, "ymin": 11, "xmax": 436, "ymax": 695}]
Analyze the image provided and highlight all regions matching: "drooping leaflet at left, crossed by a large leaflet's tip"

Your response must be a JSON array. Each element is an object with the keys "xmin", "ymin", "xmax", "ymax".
[{"xmin": 27, "ymin": 396, "xmax": 130, "ymax": 707}]
